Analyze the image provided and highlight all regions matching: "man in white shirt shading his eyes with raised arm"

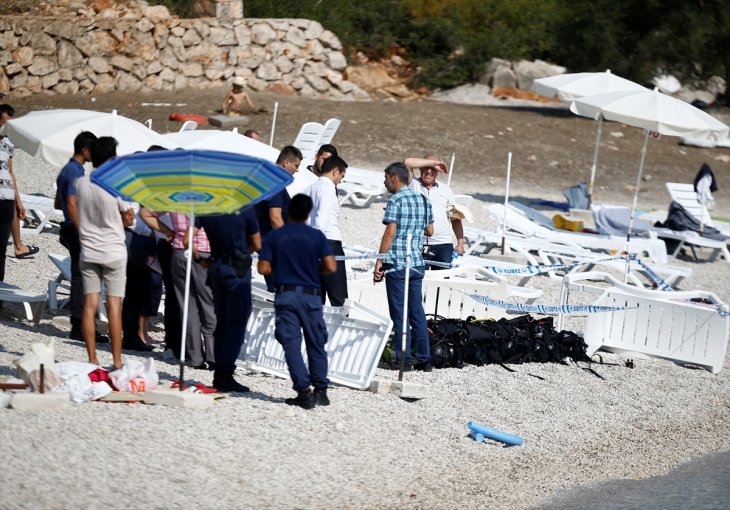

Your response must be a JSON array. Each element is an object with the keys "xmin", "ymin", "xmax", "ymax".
[{"xmin": 404, "ymin": 155, "xmax": 464, "ymax": 269}]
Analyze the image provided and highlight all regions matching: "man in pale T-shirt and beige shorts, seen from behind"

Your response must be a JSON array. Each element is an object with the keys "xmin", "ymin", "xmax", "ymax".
[{"xmin": 76, "ymin": 136, "xmax": 134, "ymax": 368}]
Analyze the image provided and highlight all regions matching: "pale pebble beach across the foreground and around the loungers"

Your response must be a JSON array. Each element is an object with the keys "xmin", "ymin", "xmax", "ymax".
[{"xmin": 0, "ymin": 133, "xmax": 730, "ymax": 510}]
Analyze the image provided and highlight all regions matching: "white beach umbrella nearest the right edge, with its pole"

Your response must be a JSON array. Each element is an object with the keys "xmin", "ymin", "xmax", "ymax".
[{"xmin": 570, "ymin": 89, "xmax": 730, "ymax": 276}]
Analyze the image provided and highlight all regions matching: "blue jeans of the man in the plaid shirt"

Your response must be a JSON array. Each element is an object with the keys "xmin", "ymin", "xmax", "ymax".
[{"xmin": 385, "ymin": 266, "xmax": 431, "ymax": 366}]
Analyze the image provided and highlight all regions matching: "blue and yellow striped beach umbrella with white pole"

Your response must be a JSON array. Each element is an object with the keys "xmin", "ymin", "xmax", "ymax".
[{"xmin": 91, "ymin": 150, "xmax": 292, "ymax": 391}]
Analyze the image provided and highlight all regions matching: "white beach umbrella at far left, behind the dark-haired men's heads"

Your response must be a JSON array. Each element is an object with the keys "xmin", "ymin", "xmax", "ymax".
[{"xmin": 3, "ymin": 109, "xmax": 164, "ymax": 166}]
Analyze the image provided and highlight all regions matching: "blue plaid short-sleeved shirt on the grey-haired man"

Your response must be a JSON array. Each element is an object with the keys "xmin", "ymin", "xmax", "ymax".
[{"xmin": 383, "ymin": 186, "xmax": 433, "ymax": 269}]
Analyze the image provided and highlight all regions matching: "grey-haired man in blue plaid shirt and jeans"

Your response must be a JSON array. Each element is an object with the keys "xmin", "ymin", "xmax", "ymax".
[{"xmin": 373, "ymin": 163, "xmax": 433, "ymax": 371}]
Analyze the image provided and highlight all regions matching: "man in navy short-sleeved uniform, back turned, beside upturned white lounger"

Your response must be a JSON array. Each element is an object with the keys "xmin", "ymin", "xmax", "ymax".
[{"xmin": 258, "ymin": 194, "xmax": 337, "ymax": 409}]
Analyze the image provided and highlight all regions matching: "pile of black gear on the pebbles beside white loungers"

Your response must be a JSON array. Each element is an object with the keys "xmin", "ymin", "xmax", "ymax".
[{"xmin": 428, "ymin": 315, "xmax": 591, "ymax": 368}]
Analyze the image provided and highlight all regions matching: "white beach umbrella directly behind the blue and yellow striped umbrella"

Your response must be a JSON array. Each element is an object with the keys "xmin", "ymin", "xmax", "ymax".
[{"xmin": 161, "ymin": 128, "xmax": 317, "ymax": 196}]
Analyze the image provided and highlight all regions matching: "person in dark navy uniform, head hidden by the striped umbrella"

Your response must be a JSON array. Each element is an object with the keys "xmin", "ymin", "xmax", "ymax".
[{"xmin": 193, "ymin": 207, "xmax": 261, "ymax": 393}]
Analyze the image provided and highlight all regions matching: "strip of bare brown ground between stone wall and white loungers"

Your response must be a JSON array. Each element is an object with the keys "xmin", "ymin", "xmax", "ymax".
[{"xmin": 5, "ymin": 88, "xmax": 730, "ymax": 215}]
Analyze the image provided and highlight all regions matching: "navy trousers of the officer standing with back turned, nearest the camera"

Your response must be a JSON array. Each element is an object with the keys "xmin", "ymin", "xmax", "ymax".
[{"xmin": 274, "ymin": 289, "xmax": 329, "ymax": 391}]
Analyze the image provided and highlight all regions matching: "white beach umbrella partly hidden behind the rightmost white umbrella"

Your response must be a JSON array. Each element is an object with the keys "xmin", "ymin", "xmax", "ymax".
[{"xmin": 532, "ymin": 69, "xmax": 648, "ymax": 206}]
